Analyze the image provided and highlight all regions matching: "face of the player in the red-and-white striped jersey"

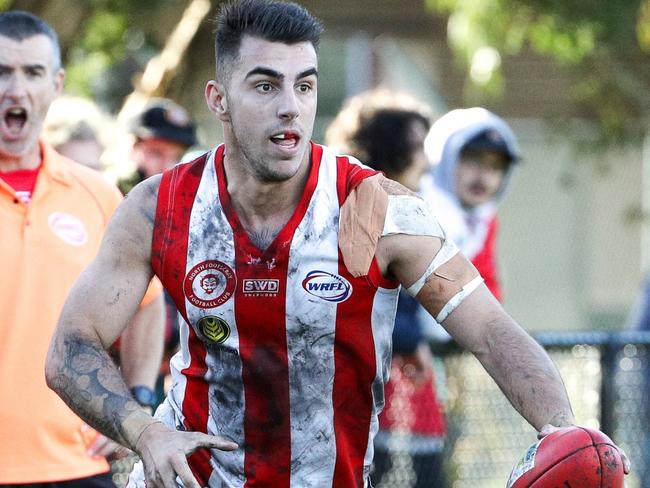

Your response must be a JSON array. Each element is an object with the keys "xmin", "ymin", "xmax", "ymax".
[{"xmin": 206, "ymin": 36, "xmax": 318, "ymax": 182}]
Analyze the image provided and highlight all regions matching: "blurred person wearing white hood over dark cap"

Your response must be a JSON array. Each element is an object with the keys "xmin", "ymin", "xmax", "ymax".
[{"xmin": 421, "ymin": 107, "xmax": 521, "ymax": 300}]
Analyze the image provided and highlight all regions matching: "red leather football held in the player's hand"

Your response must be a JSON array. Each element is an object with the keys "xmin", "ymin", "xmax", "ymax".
[{"xmin": 507, "ymin": 427, "xmax": 624, "ymax": 488}]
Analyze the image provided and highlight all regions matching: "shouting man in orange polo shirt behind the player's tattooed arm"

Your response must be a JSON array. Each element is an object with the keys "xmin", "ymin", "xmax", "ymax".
[{"xmin": 0, "ymin": 11, "xmax": 163, "ymax": 487}]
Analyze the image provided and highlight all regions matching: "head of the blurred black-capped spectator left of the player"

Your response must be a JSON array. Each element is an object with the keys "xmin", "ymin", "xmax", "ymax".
[{"xmin": 118, "ymin": 99, "xmax": 197, "ymax": 193}]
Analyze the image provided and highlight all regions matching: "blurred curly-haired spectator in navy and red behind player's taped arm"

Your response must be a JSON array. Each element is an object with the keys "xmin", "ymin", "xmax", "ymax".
[{"xmin": 326, "ymin": 89, "xmax": 446, "ymax": 488}]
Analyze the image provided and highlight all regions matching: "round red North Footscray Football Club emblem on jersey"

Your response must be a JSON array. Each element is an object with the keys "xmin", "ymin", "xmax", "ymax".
[{"xmin": 184, "ymin": 261, "xmax": 237, "ymax": 308}]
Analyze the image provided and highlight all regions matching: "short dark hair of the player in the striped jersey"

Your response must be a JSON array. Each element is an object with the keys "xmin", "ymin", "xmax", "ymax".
[{"xmin": 214, "ymin": 0, "xmax": 323, "ymax": 78}]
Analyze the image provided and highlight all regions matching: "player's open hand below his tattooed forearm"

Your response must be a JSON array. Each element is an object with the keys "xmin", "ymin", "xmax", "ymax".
[{"xmin": 135, "ymin": 422, "xmax": 238, "ymax": 488}]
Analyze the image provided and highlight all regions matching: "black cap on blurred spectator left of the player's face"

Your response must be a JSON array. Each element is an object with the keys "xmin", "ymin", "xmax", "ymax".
[{"xmin": 132, "ymin": 100, "xmax": 196, "ymax": 147}]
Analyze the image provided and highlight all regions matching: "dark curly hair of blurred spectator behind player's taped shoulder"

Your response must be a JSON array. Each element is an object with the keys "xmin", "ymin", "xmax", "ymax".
[{"xmin": 352, "ymin": 108, "xmax": 431, "ymax": 178}]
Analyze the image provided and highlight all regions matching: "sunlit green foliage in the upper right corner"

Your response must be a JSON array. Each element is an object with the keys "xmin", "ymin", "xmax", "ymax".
[{"xmin": 425, "ymin": 0, "xmax": 650, "ymax": 142}]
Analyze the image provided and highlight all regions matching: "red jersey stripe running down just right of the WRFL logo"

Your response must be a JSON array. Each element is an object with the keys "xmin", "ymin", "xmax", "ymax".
[{"xmin": 332, "ymin": 251, "xmax": 377, "ymax": 488}]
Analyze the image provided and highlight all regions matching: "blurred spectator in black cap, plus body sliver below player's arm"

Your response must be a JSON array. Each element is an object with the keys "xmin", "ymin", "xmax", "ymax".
[{"xmin": 118, "ymin": 99, "xmax": 196, "ymax": 404}]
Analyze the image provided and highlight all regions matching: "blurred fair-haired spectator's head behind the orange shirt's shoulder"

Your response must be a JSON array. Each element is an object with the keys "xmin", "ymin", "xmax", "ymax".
[{"xmin": 43, "ymin": 96, "xmax": 113, "ymax": 171}]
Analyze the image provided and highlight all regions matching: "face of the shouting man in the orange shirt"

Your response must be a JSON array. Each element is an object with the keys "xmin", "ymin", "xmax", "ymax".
[{"xmin": 0, "ymin": 34, "xmax": 63, "ymax": 164}]
